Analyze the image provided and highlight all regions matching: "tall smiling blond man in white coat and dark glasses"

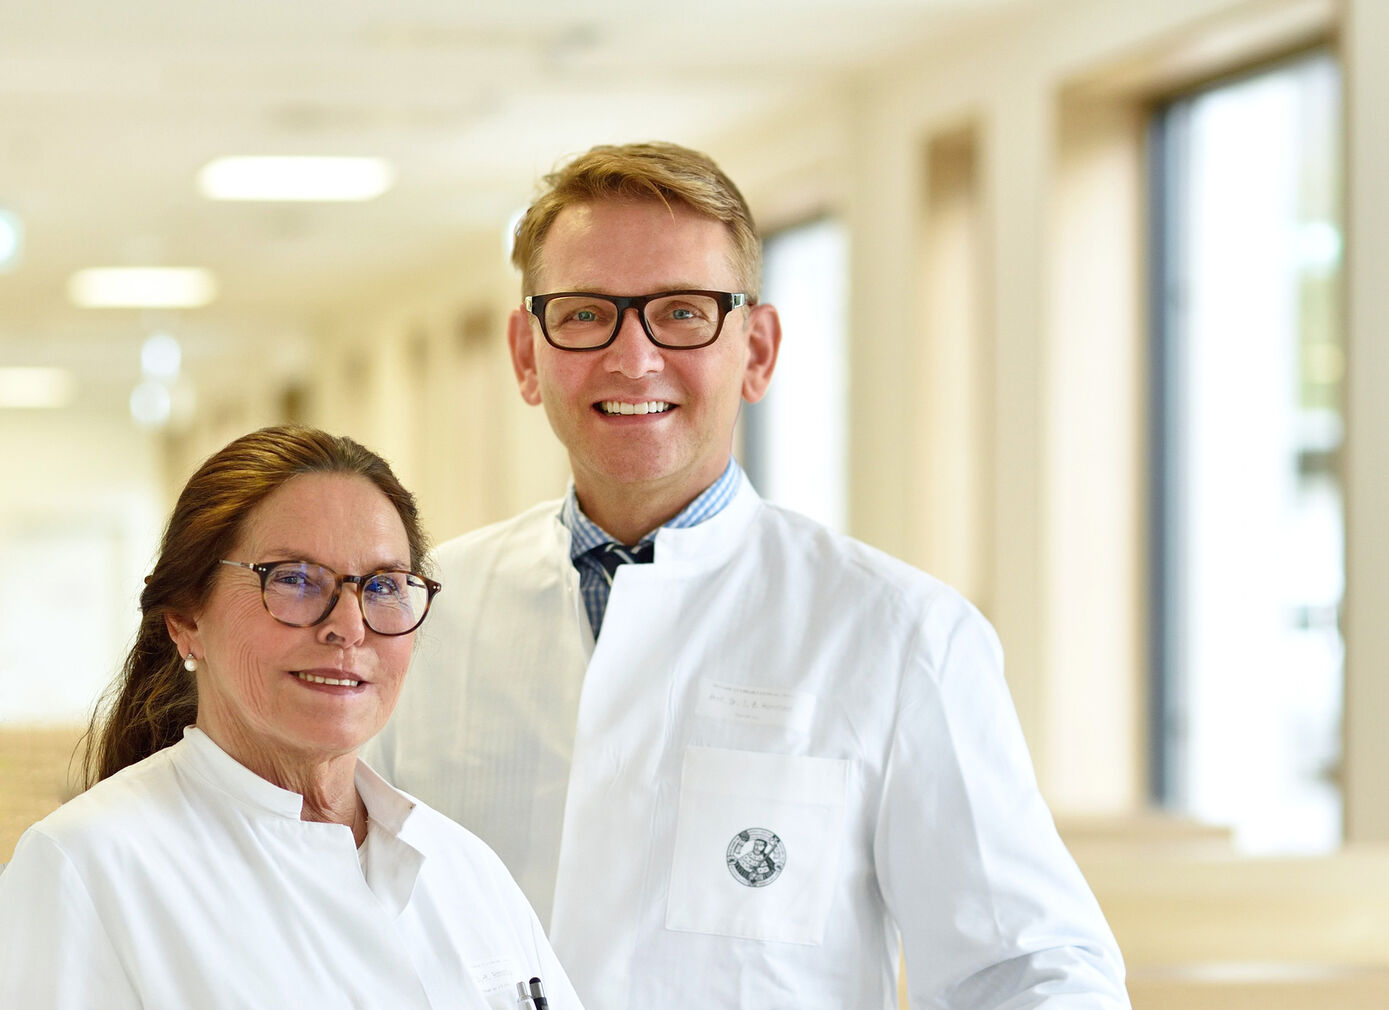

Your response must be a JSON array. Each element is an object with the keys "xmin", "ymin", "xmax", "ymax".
[{"xmin": 374, "ymin": 144, "xmax": 1128, "ymax": 1010}]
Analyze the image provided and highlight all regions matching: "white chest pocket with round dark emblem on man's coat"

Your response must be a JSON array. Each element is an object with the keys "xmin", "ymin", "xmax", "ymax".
[{"xmin": 665, "ymin": 747, "xmax": 849, "ymax": 945}]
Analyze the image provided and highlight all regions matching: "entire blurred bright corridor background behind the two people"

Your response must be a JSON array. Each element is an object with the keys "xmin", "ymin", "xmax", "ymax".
[{"xmin": 0, "ymin": 0, "xmax": 1389, "ymax": 1009}]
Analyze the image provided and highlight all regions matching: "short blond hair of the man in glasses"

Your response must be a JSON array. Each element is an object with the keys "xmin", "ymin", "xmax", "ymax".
[{"xmin": 511, "ymin": 142, "xmax": 763, "ymax": 301}]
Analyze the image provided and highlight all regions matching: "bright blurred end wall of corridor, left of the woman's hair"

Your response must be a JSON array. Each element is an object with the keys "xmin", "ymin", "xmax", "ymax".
[{"xmin": 0, "ymin": 410, "xmax": 165, "ymax": 725}]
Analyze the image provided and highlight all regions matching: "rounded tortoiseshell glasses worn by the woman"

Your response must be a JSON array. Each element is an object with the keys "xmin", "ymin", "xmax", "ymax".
[{"xmin": 221, "ymin": 560, "xmax": 443, "ymax": 635}]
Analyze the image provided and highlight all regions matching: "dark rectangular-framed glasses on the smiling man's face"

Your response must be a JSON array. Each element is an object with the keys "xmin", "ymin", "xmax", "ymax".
[{"xmin": 525, "ymin": 290, "xmax": 747, "ymax": 350}]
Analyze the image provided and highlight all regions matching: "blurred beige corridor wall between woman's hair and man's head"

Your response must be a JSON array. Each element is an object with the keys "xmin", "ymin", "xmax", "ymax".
[{"xmin": 306, "ymin": 236, "xmax": 568, "ymax": 539}]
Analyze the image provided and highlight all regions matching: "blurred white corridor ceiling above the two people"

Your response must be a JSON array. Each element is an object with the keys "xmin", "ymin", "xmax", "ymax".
[{"xmin": 0, "ymin": 0, "xmax": 1025, "ymax": 414}]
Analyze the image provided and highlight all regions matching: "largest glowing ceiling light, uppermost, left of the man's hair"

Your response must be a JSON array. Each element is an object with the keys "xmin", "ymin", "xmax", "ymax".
[{"xmin": 197, "ymin": 157, "xmax": 396, "ymax": 200}]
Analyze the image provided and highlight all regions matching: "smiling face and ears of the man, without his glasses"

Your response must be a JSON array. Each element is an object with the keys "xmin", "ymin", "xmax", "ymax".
[{"xmin": 510, "ymin": 200, "xmax": 781, "ymax": 514}]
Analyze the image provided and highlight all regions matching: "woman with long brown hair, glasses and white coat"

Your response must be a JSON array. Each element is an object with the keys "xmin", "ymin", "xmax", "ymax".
[{"xmin": 0, "ymin": 428, "xmax": 578, "ymax": 1010}]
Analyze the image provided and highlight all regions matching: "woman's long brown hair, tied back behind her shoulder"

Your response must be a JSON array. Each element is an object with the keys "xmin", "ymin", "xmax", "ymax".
[{"xmin": 82, "ymin": 425, "xmax": 428, "ymax": 786}]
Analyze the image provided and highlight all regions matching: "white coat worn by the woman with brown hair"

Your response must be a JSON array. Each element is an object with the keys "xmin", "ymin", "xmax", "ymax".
[{"xmin": 0, "ymin": 728, "xmax": 578, "ymax": 1010}]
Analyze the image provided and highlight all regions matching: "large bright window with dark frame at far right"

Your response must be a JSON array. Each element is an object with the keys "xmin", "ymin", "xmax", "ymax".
[{"xmin": 1153, "ymin": 53, "xmax": 1345, "ymax": 853}]
